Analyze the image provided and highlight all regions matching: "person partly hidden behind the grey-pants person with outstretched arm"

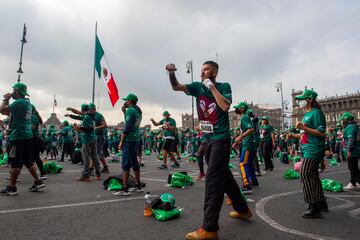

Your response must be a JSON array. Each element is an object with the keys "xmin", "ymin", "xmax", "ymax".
[{"xmin": 89, "ymin": 103, "xmax": 110, "ymax": 173}]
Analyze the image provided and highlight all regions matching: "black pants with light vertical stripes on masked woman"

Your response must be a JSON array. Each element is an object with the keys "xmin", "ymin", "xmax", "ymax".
[{"xmin": 300, "ymin": 158, "xmax": 325, "ymax": 204}]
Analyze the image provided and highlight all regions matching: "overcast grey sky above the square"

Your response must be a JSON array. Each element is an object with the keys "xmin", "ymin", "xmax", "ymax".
[{"xmin": 0, "ymin": 0, "xmax": 360, "ymax": 126}]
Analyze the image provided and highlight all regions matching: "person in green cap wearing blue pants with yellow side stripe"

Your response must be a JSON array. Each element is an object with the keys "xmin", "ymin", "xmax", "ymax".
[{"xmin": 233, "ymin": 102, "xmax": 259, "ymax": 193}]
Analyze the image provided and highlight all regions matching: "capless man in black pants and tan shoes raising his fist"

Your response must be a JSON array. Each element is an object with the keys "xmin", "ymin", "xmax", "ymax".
[{"xmin": 166, "ymin": 61, "xmax": 252, "ymax": 239}]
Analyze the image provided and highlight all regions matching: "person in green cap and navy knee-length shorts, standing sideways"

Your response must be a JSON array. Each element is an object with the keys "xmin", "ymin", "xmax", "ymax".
[{"xmin": 113, "ymin": 93, "xmax": 143, "ymax": 196}]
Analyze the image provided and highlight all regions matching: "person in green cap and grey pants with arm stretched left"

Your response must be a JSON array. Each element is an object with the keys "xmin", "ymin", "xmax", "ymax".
[{"xmin": 65, "ymin": 103, "xmax": 101, "ymax": 182}]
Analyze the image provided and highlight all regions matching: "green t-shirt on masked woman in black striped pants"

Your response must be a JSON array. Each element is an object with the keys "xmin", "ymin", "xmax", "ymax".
[{"xmin": 301, "ymin": 108, "xmax": 326, "ymax": 160}]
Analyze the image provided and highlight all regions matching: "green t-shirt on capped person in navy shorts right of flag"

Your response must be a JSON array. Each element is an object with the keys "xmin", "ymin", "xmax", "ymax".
[{"xmin": 123, "ymin": 107, "xmax": 142, "ymax": 142}]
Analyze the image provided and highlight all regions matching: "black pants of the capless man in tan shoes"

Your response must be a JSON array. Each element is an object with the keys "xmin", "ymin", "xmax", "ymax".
[{"xmin": 203, "ymin": 139, "xmax": 248, "ymax": 232}]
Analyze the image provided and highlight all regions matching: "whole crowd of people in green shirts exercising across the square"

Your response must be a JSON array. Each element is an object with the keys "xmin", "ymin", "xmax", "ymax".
[{"xmin": 0, "ymin": 61, "xmax": 360, "ymax": 239}]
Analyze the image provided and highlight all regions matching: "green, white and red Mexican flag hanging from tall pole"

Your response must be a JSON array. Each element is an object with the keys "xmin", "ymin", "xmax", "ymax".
[{"xmin": 95, "ymin": 36, "xmax": 119, "ymax": 107}]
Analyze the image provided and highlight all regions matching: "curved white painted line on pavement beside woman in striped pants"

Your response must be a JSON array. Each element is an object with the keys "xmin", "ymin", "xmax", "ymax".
[{"xmin": 255, "ymin": 190, "xmax": 341, "ymax": 240}]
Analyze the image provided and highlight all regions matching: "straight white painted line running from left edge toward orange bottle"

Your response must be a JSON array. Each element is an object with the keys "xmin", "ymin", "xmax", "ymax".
[{"xmin": 0, "ymin": 197, "xmax": 144, "ymax": 214}]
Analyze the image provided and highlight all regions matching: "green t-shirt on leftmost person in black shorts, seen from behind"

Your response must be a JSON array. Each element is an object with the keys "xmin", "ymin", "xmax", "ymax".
[{"xmin": 9, "ymin": 98, "xmax": 33, "ymax": 141}]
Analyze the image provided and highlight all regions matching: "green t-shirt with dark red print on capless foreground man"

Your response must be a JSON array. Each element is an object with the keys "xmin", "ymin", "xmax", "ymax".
[{"xmin": 186, "ymin": 82, "xmax": 232, "ymax": 140}]
